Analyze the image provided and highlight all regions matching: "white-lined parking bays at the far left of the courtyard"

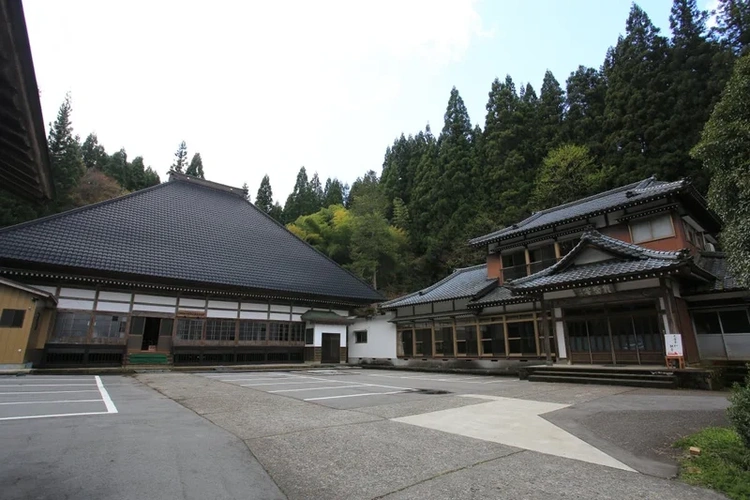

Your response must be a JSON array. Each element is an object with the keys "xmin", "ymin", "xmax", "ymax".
[{"xmin": 0, "ymin": 375, "xmax": 117, "ymax": 422}]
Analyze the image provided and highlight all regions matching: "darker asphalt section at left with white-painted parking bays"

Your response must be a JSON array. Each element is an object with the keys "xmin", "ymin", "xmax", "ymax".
[{"xmin": 0, "ymin": 375, "xmax": 285, "ymax": 500}]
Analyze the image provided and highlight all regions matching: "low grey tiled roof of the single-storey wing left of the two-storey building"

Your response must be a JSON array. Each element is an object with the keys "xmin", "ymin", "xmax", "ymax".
[{"xmin": 380, "ymin": 264, "xmax": 497, "ymax": 309}]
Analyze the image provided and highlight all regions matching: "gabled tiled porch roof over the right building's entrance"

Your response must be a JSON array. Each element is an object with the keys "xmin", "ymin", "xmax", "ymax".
[{"xmin": 508, "ymin": 231, "xmax": 690, "ymax": 292}]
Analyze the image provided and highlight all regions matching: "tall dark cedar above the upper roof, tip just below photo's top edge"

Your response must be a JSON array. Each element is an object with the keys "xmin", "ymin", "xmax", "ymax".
[{"xmin": 605, "ymin": 4, "xmax": 679, "ymax": 184}]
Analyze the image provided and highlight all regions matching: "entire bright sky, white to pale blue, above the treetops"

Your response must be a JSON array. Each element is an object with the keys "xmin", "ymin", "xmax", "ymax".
[{"xmin": 24, "ymin": 0, "xmax": 715, "ymax": 205}]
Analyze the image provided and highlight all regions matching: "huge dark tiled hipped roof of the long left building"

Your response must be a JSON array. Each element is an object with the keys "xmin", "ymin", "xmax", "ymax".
[{"xmin": 0, "ymin": 176, "xmax": 383, "ymax": 303}]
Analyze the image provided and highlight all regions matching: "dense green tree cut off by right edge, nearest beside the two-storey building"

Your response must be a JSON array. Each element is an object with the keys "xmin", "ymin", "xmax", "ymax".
[{"xmin": 693, "ymin": 53, "xmax": 750, "ymax": 286}]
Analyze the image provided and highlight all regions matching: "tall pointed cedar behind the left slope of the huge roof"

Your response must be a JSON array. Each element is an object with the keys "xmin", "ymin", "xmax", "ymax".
[{"xmin": 47, "ymin": 94, "xmax": 86, "ymax": 211}]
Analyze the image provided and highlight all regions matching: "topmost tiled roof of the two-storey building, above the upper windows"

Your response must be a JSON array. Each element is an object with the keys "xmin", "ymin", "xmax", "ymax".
[{"xmin": 469, "ymin": 177, "xmax": 689, "ymax": 246}]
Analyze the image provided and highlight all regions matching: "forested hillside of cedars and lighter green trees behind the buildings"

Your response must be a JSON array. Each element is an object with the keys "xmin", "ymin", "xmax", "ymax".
[{"xmin": 0, "ymin": 0, "xmax": 750, "ymax": 295}]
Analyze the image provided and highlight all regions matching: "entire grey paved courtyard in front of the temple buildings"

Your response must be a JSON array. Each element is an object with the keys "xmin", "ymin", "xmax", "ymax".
[{"xmin": 0, "ymin": 369, "xmax": 727, "ymax": 500}]
